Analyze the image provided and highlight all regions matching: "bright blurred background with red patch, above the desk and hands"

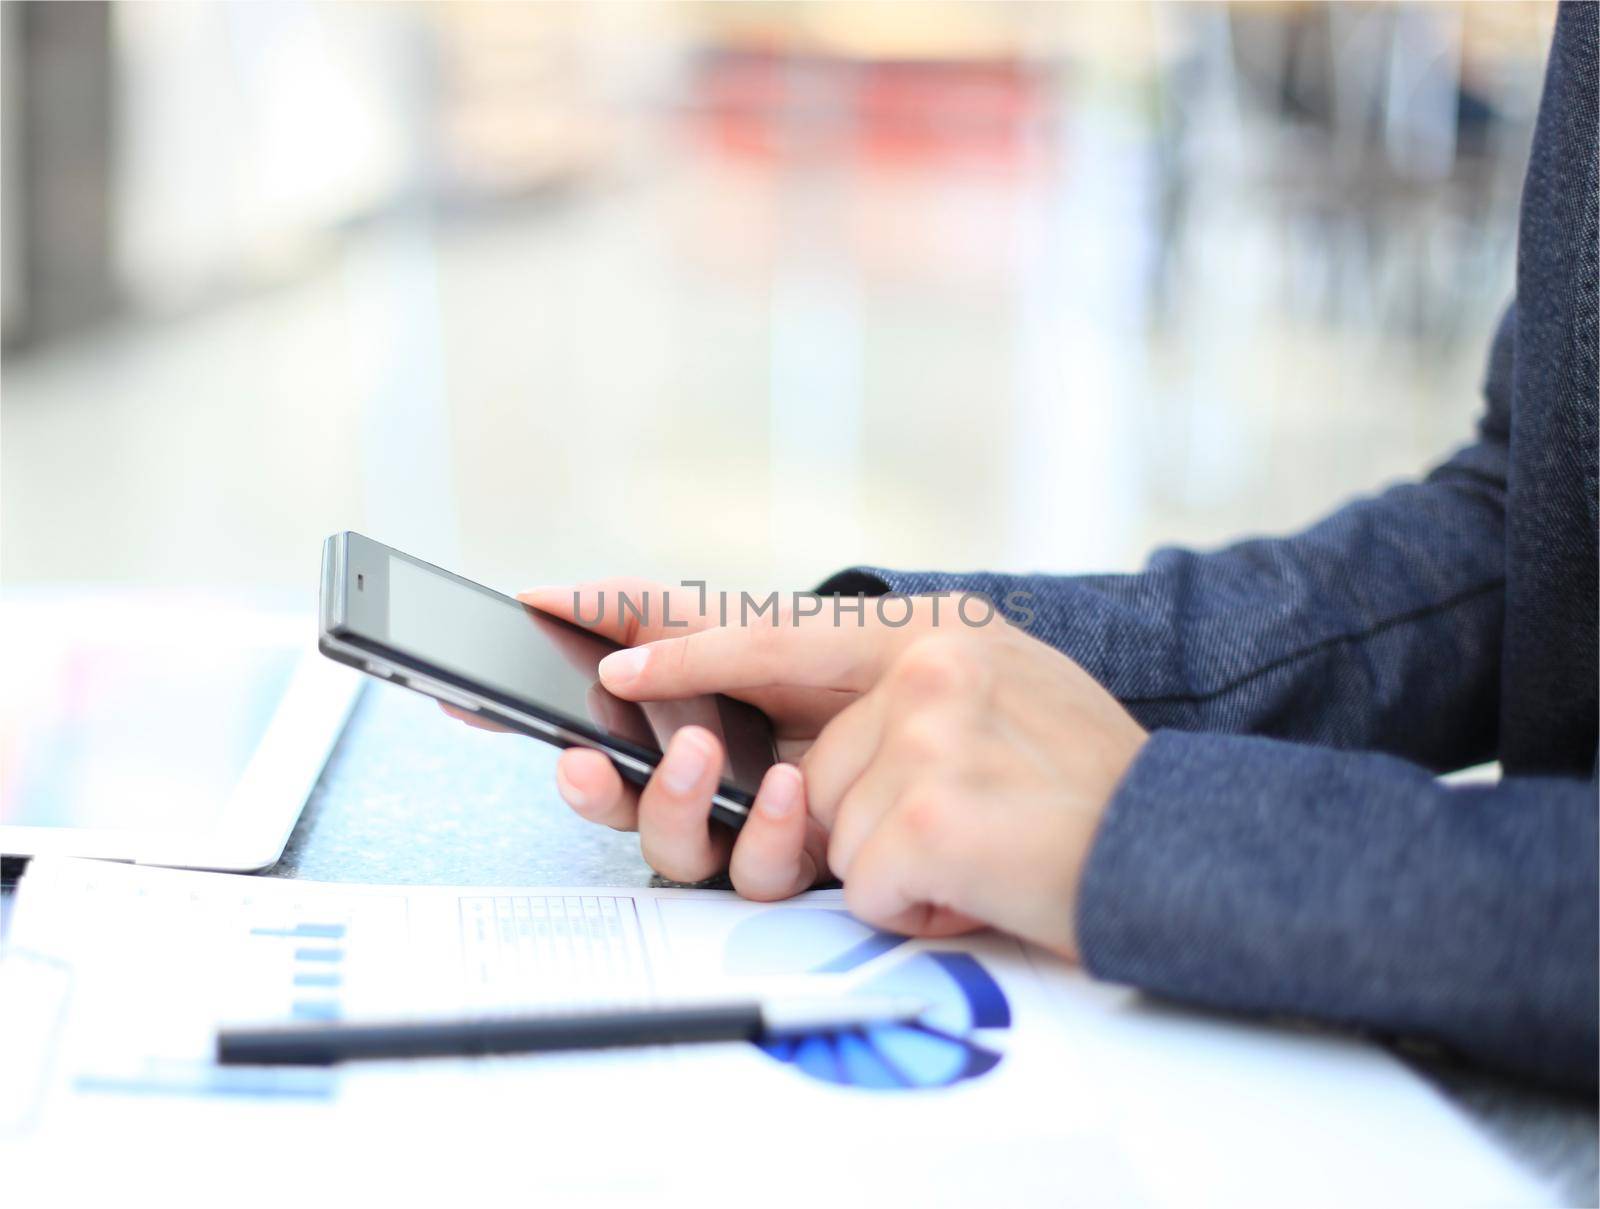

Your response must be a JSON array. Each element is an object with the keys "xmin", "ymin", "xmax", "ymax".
[{"xmin": 0, "ymin": 0, "xmax": 1554, "ymax": 605}]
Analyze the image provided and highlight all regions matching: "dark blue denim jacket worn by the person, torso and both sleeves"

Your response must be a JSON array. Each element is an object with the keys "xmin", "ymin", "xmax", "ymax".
[{"xmin": 822, "ymin": 5, "xmax": 1600, "ymax": 1087}]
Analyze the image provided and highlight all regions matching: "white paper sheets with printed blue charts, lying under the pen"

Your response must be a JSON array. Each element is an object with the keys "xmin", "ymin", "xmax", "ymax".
[{"xmin": 0, "ymin": 860, "xmax": 1549, "ymax": 1206}]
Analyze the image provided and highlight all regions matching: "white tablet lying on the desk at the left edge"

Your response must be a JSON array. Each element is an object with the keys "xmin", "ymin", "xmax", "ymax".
[{"xmin": 0, "ymin": 590, "xmax": 360, "ymax": 872}]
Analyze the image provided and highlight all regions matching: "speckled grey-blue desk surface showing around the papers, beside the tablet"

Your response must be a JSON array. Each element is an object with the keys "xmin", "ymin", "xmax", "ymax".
[{"xmin": 270, "ymin": 684, "xmax": 1600, "ymax": 1204}]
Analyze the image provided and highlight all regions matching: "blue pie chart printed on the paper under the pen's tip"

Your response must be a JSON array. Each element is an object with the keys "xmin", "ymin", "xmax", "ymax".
[{"xmin": 725, "ymin": 907, "xmax": 1011, "ymax": 1091}]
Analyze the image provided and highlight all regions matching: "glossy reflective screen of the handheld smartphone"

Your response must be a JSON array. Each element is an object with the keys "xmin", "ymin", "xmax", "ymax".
[{"xmin": 376, "ymin": 555, "xmax": 771, "ymax": 795}]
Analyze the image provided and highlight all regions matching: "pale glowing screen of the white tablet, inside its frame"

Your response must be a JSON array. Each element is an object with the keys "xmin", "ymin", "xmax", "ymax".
[{"xmin": 0, "ymin": 593, "xmax": 304, "ymax": 833}]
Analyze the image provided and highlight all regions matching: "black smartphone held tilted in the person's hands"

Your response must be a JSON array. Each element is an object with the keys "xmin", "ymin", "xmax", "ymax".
[{"xmin": 318, "ymin": 533, "xmax": 776, "ymax": 828}]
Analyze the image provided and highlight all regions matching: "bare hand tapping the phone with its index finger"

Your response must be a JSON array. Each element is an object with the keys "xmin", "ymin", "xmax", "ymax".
[{"xmin": 595, "ymin": 593, "xmax": 1146, "ymax": 958}]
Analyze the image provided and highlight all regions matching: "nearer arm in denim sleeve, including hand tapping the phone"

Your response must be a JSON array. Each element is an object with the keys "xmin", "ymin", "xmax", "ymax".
[{"xmin": 576, "ymin": 600, "xmax": 1600, "ymax": 1086}]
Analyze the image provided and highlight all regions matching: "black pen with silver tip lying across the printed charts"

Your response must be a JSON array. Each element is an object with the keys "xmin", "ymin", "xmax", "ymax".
[{"xmin": 216, "ymin": 996, "xmax": 928, "ymax": 1067}]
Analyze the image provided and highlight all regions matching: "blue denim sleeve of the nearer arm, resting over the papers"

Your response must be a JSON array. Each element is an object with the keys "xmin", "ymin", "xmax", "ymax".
[{"xmin": 1075, "ymin": 731, "xmax": 1600, "ymax": 1089}]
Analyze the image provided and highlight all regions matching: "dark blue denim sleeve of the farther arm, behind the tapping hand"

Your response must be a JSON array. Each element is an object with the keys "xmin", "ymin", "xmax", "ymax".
[{"xmin": 821, "ymin": 312, "xmax": 1514, "ymax": 769}]
